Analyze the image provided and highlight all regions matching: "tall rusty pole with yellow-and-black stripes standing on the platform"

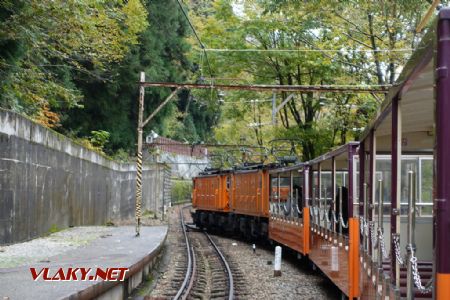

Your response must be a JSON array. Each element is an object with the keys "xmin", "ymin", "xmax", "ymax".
[{"xmin": 135, "ymin": 72, "xmax": 145, "ymax": 236}]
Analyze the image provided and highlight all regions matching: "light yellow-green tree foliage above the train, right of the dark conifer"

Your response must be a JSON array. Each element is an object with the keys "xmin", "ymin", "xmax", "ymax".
[{"xmin": 187, "ymin": 0, "xmax": 429, "ymax": 160}]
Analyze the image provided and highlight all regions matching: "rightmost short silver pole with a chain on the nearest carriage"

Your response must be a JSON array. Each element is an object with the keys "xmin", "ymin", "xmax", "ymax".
[{"xmin": 406, "ymin": 171, "xmax": 416, "ymax": 299}]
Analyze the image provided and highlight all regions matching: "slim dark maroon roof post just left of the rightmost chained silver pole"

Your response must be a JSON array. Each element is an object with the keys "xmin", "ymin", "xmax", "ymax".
[{"xmin": 390, "ymin": 97, "xmax": 402, "ymax": 292}]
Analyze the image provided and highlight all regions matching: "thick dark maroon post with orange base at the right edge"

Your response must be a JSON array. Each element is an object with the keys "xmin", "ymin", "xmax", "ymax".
[{"xmin": 434, "ymin": 8, "xmax": 450, "ymax": 300}]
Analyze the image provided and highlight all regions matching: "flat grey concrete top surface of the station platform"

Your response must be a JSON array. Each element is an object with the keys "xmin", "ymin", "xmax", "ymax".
[{"xmin": 0, "ymin": 226, "xmax": 167, "ymax": 300}]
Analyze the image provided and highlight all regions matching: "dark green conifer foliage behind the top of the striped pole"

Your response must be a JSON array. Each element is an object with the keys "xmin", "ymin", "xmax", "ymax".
[{"xmin": 62, "ymin": 0, "xmax": 219, "ymax": 155}]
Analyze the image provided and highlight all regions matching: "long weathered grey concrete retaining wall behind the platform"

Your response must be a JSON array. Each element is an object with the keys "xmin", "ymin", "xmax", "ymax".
[{"xmin": 0, "ymin": 110, "xmax": 170, "ymax": 244}]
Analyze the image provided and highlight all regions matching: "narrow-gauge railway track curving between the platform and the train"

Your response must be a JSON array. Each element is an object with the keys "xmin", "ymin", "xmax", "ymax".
[{"xmin": 173, "ymin": 206, "xmax": 235, "ymax": 300}]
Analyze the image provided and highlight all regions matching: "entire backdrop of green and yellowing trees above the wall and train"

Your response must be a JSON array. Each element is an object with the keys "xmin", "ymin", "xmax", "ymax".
[{"xmin": 0, "ymin": 0, "xmax": 429, "ymax": 160}]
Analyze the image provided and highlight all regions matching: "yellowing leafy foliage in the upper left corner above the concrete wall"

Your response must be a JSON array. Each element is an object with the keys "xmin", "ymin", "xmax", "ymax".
[{"xmin": 0, "ymin": 0, "xmax": 148, "ymax": 127}]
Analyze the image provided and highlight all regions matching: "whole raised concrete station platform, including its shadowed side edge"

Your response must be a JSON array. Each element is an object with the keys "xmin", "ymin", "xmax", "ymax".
[{"xmin": 0, "ymin": 226, "xmax": 167, "ymax": 300}]
